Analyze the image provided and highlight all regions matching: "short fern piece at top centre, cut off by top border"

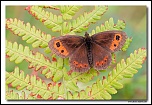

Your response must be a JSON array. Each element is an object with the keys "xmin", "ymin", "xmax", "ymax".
[{"xmin": 60, "ymin": 5, "xmax": 82, "ymax": 20}]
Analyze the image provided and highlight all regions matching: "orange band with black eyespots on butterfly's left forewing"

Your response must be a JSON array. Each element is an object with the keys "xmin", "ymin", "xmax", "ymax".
[{"xmin": 53, "ymin": 40, "xmax": 69, "ymax": 56}]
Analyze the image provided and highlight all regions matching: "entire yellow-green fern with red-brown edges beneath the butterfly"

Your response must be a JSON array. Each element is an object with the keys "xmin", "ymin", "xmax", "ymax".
[{"xmin": 6, "ymin": 6, "xmax": 146, "ymax": 100}]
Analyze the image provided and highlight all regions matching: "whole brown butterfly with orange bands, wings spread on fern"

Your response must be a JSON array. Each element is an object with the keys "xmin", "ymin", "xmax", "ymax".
[{"xmin": 48, "ymin": 30, "xmax": 127, "ymax": 72}]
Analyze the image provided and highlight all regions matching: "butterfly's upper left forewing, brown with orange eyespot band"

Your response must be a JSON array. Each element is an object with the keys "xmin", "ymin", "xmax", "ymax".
[{"xmin": 48, "ymin": 35, "xmax": 84, "ymax": 58}]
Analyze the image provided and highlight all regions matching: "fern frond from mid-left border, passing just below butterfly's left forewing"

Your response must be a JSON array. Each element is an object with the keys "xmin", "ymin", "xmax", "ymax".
[{"xmin": 6, "ymin": 41, "xmax": 63, "ymax": 81}]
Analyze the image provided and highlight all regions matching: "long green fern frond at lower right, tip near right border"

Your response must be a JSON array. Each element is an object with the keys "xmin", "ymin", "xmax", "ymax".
[{"xmin": 68, "ymin": 48, "xmax": 146, "ymax": 100}]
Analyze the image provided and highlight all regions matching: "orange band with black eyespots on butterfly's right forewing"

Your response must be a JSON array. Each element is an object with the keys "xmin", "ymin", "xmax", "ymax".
[{"xmin": 110, "ymin": 34, "xmax": 122, "ymax": 51}]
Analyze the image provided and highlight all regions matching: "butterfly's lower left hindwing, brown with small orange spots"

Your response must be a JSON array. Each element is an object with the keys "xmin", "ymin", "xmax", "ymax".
[{"xmin": 69, "ymin": 43, "xmax": 90, "ymax": 72}]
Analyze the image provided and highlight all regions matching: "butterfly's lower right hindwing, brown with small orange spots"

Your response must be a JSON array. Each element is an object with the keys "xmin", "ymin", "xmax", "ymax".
[{"xmin": 92, "ymin": 43, "xmax": 111, "ymax": 70}]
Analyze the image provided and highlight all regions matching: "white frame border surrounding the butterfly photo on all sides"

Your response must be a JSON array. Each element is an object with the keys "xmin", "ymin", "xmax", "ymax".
[{"xmin": 1, "ymin": 1, "xmax": 151, "ymax": 104}]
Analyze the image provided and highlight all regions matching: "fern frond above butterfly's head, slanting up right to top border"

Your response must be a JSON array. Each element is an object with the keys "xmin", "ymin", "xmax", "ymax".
[{"xmin": 68, "ymin": 6, "xmax": 108, "ymax": 33}]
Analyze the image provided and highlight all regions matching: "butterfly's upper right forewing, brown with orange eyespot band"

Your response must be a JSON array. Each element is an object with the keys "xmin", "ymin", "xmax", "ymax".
[{"xmin": 91, "ymin": 30, "xmax": 127, "ymax": 52}]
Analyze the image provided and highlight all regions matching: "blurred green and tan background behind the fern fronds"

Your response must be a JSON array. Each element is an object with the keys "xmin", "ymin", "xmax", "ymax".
[{"xmin": 6, "ymin": 6, "xmax": 147, "ymax": 100}]
